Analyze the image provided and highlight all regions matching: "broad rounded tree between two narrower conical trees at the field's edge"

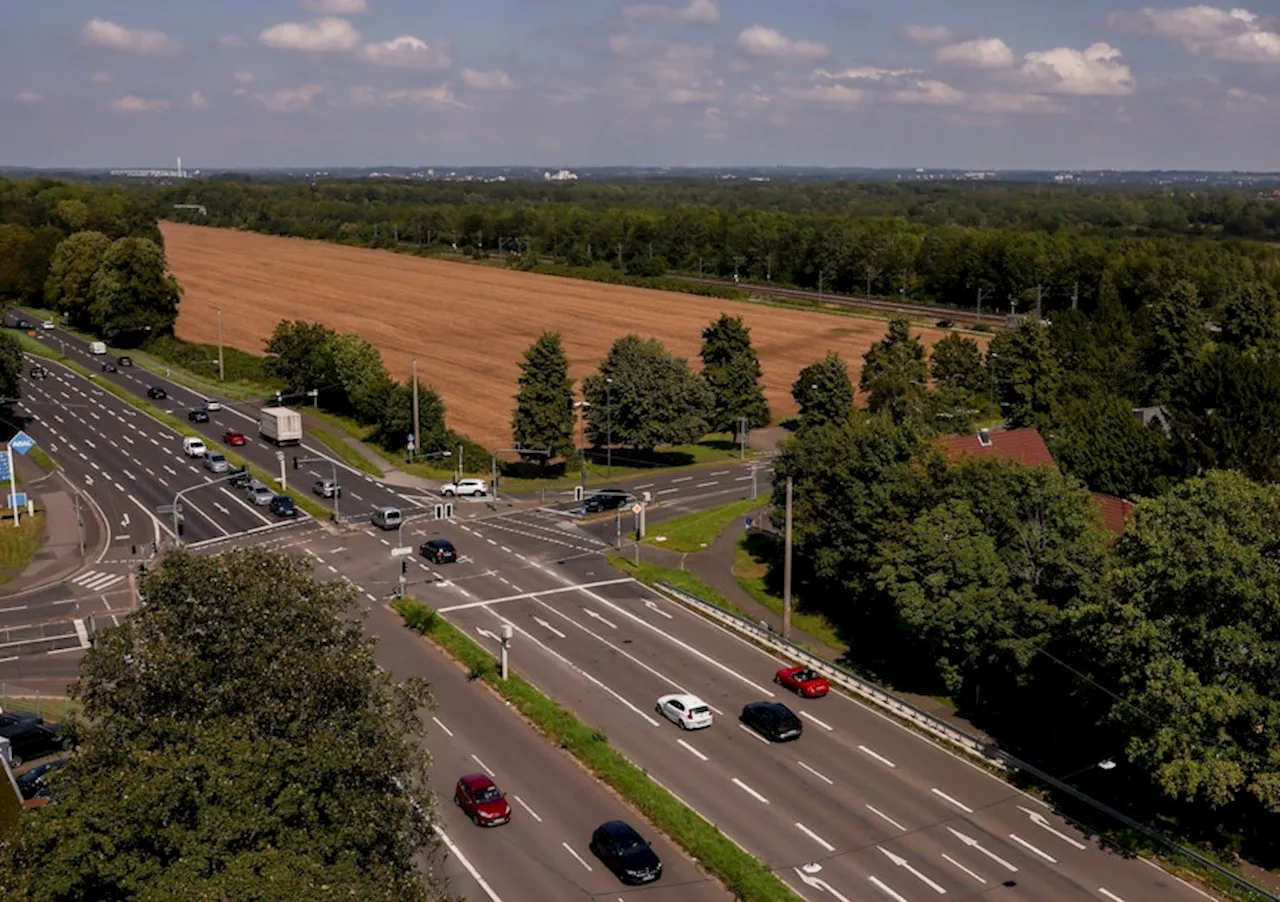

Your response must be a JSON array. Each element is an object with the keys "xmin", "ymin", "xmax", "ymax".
[{"xmin": 582, "ymin": 335, "xmax": 712, "ymax": 450}]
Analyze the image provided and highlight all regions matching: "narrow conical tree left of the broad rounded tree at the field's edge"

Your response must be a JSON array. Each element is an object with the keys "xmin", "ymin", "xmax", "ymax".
[{"xmin": 511, "ymin": 331, "xmax": 575, "ymax": 464}]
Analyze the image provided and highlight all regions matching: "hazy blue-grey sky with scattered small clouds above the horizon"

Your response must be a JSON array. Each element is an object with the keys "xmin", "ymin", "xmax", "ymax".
[{"xmin": 0, "ymin": 0, "xmax": 1280, "ymax": 170}]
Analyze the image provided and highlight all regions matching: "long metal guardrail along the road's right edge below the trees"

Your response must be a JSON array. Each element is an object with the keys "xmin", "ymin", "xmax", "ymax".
[{"xmin": 658, "ymin": 582, "xmax": 1280, "ymax": 902}]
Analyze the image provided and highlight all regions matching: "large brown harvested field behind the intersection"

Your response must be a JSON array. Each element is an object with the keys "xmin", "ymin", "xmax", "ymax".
[{"xmin": 161, "ymin": 223, "xmax": 962, "ymax": 447}]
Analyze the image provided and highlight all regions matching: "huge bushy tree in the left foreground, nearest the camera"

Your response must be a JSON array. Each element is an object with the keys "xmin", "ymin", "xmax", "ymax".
[{"xmin": 0, "ymin": 549, "xmax": 442, "ymax": 902}]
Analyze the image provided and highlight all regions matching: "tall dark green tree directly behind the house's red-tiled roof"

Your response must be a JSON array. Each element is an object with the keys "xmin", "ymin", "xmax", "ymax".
[{"xmin": 987, "ymin": 319, "xmax": 1061, "ymax": 426}]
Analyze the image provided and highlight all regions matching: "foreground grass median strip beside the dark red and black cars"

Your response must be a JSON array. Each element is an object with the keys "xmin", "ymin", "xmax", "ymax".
[{"xmin": 394, "ymin": 599, "xmax": 799, "ymax": 902}]
